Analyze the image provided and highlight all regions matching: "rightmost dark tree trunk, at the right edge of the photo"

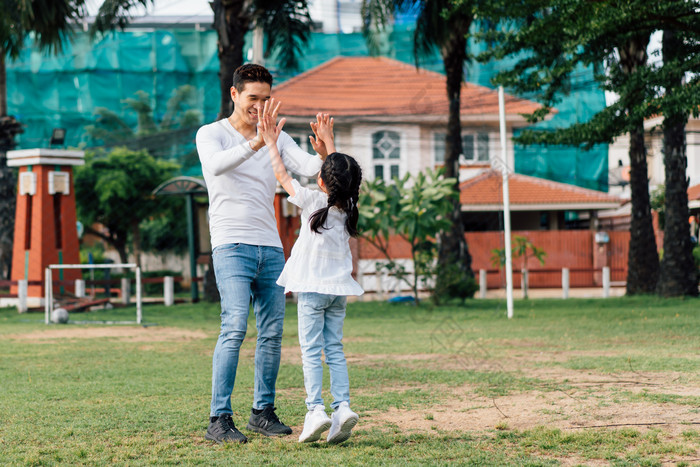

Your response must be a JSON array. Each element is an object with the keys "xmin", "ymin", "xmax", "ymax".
[{"xmin": 657, "ymin": 30, "xmax": 698, "ymax": 297}]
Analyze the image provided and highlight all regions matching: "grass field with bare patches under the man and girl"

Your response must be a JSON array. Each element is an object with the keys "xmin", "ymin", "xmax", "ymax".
[{"xmin": 0, "ymin": 297, "xmax": 700, "ymax": 466}]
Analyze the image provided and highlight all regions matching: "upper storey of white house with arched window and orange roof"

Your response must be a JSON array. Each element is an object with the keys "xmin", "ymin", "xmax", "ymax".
[{"xmin": 272, "ymin": 57, "xmax": 540, "ymax": 185}]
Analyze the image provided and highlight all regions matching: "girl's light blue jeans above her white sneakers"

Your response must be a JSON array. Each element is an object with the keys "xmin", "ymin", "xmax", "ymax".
[{"xmin": 297, "ymin": 292, "xmax": 350, "ymax": 410}]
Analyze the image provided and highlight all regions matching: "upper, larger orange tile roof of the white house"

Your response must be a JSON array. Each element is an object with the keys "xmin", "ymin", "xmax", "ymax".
[{"xmin": 272, "ymin": 57, "xmax": 540, "ymax": 117}]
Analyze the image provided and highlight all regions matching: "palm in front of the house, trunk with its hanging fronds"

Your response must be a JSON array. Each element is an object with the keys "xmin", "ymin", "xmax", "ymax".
[{"xmin": 362, "ymin": 0, "xmax": 477, "ymax": 300}]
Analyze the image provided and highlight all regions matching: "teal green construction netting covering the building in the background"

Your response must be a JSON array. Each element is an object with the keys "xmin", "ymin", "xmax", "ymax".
[{"xmin": 7, "ymin": 27, "xmax": 608, "ymax": 191}]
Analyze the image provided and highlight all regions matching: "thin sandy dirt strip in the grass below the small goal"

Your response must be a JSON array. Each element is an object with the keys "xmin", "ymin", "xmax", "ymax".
[{"xmin": 3, "ymin": 326, "xmax": 209, "ymax": 342}]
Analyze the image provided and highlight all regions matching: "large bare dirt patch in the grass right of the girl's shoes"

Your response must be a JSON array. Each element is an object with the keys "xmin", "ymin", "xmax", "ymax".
[{"xmin": 361, "ymin": 378, "xmax": 700, "ymax": 465}]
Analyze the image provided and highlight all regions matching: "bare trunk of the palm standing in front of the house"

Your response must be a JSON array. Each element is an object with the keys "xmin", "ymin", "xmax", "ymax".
[{"xmin": 436, "ymin": 25, "xmax": 474, "ymax": 290}]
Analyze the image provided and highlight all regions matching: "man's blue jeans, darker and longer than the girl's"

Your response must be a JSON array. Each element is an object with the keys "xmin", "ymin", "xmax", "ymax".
[{"xmin": 211, "ymin": 243, "xmax": 284, "ymax": 416}]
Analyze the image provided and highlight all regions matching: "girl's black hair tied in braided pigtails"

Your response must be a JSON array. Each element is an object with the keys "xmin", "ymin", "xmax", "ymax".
[{"xmin": 309, "ymin": 152, "xmax": 362, "ymax": 237}]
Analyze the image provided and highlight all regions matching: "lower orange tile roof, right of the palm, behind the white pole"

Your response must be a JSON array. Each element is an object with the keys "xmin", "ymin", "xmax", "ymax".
[{"xmin": 459, "ymin": 170, "xmax": 622, "ymax": 211}]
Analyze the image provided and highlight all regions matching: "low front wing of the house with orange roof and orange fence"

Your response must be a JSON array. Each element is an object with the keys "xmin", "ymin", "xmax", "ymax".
[{"xmin": 358, "ymin": 169, "xmax": 629, "ymax": 290}]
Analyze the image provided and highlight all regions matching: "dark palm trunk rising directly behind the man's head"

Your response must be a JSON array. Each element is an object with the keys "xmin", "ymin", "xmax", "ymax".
[{"xmin": 211, "ymin": 0, "xmax": 252, "ymax": 119}]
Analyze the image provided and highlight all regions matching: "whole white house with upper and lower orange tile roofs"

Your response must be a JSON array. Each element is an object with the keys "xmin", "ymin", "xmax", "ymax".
[{"xmin": 272, "ymin": 57, "xmax": 626, "ymax": 291}]
